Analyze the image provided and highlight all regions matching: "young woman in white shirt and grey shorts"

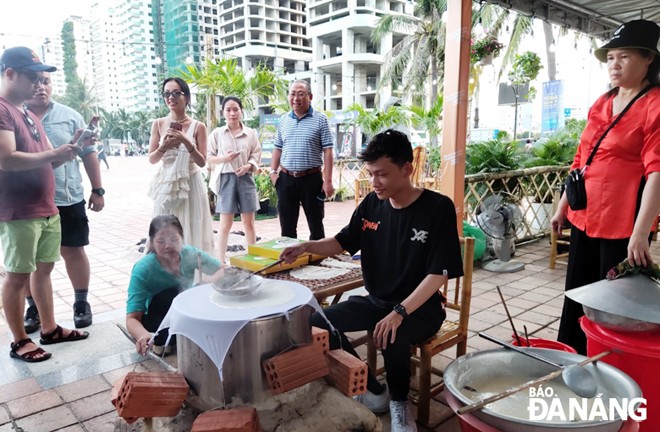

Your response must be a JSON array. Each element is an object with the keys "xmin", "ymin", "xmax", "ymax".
[{"xmin": 207, "ymin": 96, "xmax": 261, "ymax": 262}]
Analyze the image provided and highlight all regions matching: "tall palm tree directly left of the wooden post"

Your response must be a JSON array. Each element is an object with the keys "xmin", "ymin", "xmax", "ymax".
[{"xmin": 371, "ymin": 0, "xmax": 447, "ymax": 104}]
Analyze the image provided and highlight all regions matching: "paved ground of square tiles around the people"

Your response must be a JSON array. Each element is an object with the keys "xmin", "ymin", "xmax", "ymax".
[{"xmin": 0, "ymin": 157, "xmax": 660, "ymax": 432}]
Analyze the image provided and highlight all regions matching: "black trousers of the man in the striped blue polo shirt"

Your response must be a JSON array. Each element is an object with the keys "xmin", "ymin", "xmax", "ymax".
[{"xmin": 275, "ymin": 171, "xmax": 325, "ymax": 240}]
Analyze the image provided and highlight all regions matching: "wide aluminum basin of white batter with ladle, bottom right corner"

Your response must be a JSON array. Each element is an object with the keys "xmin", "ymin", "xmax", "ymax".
[{"xmin": 444, "ymin": 348, "xmax": 642, "ymax": 432}]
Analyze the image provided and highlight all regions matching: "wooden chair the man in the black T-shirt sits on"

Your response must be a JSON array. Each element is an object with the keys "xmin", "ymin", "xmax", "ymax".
[{"xmin": 367, "ymin": 237, "xmax": 474, "ymax": 425}]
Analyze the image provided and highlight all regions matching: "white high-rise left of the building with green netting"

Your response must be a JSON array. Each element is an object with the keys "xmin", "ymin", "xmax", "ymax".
[{"xmin": 90, "ymin": 0, "xmax": 160, "ymax": 112}]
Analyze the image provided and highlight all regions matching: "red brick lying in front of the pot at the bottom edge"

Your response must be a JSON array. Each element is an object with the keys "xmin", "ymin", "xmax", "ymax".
[{"xmin": 191, "ymin": 407, "xmax": 261, "ymax": 432}]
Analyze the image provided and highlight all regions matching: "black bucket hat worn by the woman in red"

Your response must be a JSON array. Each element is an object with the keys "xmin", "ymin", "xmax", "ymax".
[{"xmin": 594, "ymin": 20, "xmax": 660, "ymax": 63}]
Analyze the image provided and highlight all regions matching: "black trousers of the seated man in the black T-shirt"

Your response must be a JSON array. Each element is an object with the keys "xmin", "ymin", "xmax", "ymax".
[{"xmin": 311, "ymin": 296, "xmax": 447, "ymax": 401}]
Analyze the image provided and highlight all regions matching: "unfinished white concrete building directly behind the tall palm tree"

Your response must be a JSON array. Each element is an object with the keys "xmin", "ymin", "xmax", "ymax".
[{"xmin": 307, "ymin": 0, "xmax": 410, "ymax": 110}]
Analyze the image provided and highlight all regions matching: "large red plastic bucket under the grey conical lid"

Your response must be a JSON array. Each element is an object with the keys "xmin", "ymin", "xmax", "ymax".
[{"xmin": 580, "ymin": 317, "xmax": 660, "ymax": 432}]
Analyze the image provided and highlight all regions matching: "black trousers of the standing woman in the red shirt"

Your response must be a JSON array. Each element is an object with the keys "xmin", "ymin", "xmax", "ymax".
[{"xmin": 557, "ymin": 227, "xmax": 629, "ymax": 355}]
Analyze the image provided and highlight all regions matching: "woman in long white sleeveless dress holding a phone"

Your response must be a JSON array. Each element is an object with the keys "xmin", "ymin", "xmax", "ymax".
[{"xmin": 149, "ymin": 78, "xmax": 213, "ymax": 253}]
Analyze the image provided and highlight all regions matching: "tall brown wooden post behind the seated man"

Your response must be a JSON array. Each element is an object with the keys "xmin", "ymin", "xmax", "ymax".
[{"xmin": 440, "ymin": 0, "xmax": 472, "ymax": 234}]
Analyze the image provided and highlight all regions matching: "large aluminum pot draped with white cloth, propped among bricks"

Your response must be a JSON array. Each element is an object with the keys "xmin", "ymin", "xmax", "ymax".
[{"xmin": 177, "ymin": 305, "xmax": 314, "ymax": 411}]
